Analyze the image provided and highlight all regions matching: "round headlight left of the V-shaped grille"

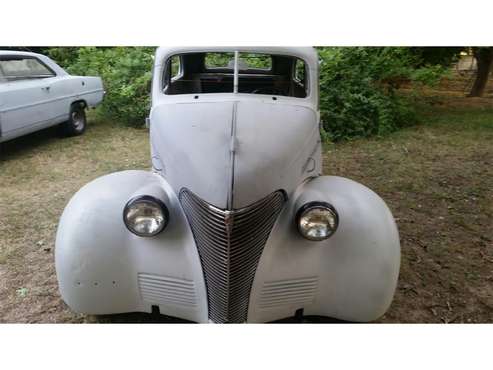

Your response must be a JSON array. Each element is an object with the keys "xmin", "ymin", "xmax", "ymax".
[{"xmin": 123, "ymin": 195, "xmax": 169, "ymax": 236}]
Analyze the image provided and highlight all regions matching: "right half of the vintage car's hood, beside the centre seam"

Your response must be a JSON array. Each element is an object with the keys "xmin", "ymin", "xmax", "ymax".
[{"xmin": 233, "ymin": 100, "xmax": 321, "ymax": 209}]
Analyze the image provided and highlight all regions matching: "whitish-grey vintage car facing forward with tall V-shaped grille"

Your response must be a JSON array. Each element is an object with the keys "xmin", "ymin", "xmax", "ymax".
[{"xmin": 55, "ymin": 47, "xmax": 400, "ymax": 323}]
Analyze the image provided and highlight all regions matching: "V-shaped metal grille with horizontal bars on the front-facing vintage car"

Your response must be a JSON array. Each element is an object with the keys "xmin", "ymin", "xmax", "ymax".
[{"xmin": 180, "ymin": 189, "xmax": 286, "ymax": 323}]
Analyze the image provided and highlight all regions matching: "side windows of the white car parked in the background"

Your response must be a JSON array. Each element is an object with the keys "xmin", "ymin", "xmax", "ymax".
[{"xmin": 0, "ymin": 56, "xmax": 56, "ymax": 81}]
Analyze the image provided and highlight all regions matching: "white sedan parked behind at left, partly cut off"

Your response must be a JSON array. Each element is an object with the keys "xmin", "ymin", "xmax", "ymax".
[{"xmin": 0, "ymin": 50, "xmax": 104, "ymax": 142}]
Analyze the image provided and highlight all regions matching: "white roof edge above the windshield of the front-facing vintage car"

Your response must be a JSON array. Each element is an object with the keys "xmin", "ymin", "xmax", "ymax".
[{"xmin": 156, "ymin": 46, "xmax": 318, "ymax": 68}]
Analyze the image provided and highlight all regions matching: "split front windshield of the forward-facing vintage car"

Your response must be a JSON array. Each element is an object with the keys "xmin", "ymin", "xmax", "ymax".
[{"xmin": 163, "ymin": 52, "xmax": 308, "ymax": 98}]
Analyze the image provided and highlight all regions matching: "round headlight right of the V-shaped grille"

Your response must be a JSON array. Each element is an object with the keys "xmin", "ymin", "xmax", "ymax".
[{"xmin": 296, "ymin": 202, "xmax": 339, "ymax": 241}]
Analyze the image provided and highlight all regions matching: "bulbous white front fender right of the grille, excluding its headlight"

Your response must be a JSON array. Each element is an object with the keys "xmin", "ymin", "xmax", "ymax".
[{"xmin": 248, "ymin": 176, "xmax": 400, "ymax": 322}]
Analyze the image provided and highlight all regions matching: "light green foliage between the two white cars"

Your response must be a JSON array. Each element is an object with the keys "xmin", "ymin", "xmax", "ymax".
[{"xmin": 50, "ymin": 47, "xmax": 155, "ymax": 127}]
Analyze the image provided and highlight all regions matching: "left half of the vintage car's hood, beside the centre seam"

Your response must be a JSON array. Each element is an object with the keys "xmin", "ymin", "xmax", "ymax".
[{"xmin": 151, "ymin": 102, "xmax": 234, "ymax": 208}]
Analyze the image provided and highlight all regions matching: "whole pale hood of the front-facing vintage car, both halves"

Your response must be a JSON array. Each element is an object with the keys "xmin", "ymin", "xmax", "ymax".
[{"xmin": 150, "ymin": 100, "xmax": 321, "ymax": 209}]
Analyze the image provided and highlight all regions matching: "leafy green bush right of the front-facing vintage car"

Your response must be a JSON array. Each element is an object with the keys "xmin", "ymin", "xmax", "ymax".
[{"xmin": 319, "ymin": 47, "xmax": 444, "ymax": 140}]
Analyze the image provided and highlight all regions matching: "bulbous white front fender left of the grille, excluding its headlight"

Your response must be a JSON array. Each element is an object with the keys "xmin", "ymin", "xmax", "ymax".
[{"xmin": 55, "ymin": 171, "xmax": 208, "ymax": 322}]
